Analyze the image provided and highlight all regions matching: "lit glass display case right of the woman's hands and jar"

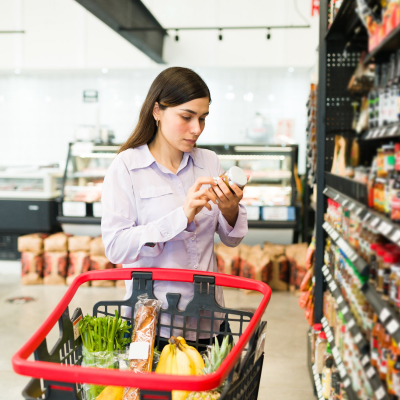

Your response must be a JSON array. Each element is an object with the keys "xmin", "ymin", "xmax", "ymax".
[{"xmin": 199, "ymin": 145, "xmax": 299, "ymax": 229}]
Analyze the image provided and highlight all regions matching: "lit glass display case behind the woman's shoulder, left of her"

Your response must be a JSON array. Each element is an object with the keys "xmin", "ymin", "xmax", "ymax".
[{"xmin": 58, "ymin": 142, "xmax": 120, "ymax": 236}]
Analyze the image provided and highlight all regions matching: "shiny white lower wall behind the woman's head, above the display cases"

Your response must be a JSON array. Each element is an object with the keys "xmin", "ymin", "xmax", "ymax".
[{"xmin": 0, "ymin": 68, "xmax": 309, "ymax": 172}]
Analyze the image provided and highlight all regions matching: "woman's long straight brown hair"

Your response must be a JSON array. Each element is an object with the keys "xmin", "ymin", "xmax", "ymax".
[{"xmin": 118, "ymin": 67, "xmax": 211, "ymax": 153}]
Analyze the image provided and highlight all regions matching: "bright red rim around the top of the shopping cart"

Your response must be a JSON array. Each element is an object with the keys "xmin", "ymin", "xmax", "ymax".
[{"xmin": 12, "ymin": 268, "xmax": 271, "ymax": 391}]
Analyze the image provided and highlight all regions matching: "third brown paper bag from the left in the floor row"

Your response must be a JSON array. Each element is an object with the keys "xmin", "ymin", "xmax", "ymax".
[{"xmin": 67, "ymin": 236, "xmax": 92, "ymax": 286}]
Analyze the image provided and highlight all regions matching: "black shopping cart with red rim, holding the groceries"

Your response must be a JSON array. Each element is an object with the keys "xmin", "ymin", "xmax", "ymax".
[{"xmin": 12, "ymin": 268, "xmax": 271, "ymax": 400}]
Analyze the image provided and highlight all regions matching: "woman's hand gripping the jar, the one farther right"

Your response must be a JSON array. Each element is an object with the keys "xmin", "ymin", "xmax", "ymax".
[{"xmin": 209, "ymin": 176, "xmax": 249, "ymax": 226}]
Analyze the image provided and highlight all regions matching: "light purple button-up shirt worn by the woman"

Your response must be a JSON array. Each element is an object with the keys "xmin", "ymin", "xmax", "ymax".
[{"xmin": 101, "ymin": 145, "xmax": 248, "ymax": 340}]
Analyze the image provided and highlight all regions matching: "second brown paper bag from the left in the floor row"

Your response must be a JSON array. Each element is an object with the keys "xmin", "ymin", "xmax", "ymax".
[{"xmin": 44, "ymin": 232, "xmax": 68, "ymax": 285}]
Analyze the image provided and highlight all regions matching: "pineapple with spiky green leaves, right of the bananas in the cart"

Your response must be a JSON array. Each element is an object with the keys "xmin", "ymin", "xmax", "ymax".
[{"xmin": 186, "ymin": 336, "xmax": 232, "ymax": 400}]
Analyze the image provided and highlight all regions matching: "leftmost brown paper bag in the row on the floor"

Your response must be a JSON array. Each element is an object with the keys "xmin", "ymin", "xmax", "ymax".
[{"xmin": 18, "ymin": 233, "xmax": 48, "ymax": 285}]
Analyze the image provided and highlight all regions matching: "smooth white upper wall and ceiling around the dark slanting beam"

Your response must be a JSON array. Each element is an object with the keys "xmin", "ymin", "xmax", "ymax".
[{"xmin": 0, "ymin": 0, "xmax": 318, "ymax": 71}]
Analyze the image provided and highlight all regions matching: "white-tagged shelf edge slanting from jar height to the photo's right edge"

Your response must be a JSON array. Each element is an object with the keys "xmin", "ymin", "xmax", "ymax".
[{"xmin": 324, "ymin": 182, "xmax": 400, "ymax": 246}]
